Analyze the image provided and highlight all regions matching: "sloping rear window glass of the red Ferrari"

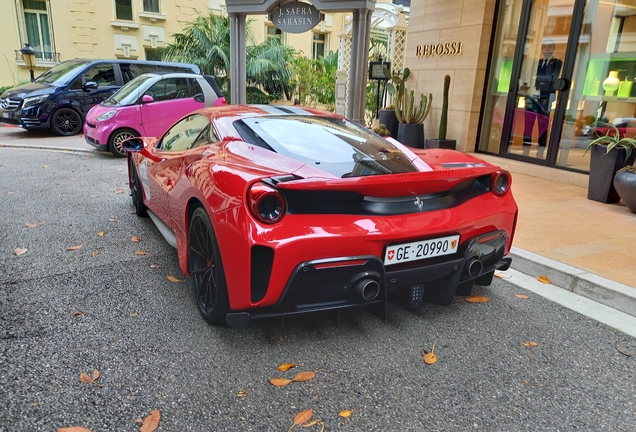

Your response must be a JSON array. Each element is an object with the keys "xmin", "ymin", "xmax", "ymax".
[{"xmin": 234, "ymin": 116, "xmax": 417, "ymax": 177}]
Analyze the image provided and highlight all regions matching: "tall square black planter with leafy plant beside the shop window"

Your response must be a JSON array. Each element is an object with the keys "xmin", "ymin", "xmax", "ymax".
[{"xmin": 587, "ymin": 145, "xmax": 636, "ymax": 203}]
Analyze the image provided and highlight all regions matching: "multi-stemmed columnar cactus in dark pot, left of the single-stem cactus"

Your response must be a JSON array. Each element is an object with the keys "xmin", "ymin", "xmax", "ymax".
[{"xmin": 395, "ymin": 83, "xmax": 433, "ymax": 148}]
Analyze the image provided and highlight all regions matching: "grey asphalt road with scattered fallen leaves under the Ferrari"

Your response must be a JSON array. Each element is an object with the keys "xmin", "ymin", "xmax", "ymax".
[{"xmin": 0, "ymin": 147, "xmax": 636, "ymax": 432}]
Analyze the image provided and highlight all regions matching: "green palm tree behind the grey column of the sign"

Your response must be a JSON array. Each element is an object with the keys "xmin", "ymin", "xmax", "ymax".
[{"xmin": 163, "ymin": 10, "xmax": 296, "ymax": 101}]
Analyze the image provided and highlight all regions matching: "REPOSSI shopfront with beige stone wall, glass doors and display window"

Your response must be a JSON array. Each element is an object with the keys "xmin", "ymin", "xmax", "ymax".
[{"xmin": 406, "ymin": 0, "xmax": 636, "ymax": 172}]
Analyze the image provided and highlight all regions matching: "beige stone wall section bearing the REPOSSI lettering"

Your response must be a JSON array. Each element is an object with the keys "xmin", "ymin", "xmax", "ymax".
[{"xmin": 405, "ymin": 0, "xmax": 496, "ymax": 151}]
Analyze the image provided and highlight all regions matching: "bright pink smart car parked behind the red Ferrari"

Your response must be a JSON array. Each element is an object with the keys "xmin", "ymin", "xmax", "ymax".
[{"xmin": 84, "ymin": 73, "xmax": 226, "ymax": 157}]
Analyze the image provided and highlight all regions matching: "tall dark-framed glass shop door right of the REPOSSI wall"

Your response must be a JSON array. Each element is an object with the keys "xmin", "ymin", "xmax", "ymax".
[{"xmin": 479, "ymin": 0, "xmax": 585, "ymax": 165}]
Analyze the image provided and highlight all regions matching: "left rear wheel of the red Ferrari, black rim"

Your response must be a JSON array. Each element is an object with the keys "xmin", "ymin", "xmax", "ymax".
[{"xmin": 188, "ymin": 207, "xmax": 230, "ymax": 324}]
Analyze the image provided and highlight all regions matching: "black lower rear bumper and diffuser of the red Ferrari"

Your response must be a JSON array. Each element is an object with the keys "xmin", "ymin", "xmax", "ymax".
[{"xmin": 226, "ymin": 231, "xmax": 512, "ymax": 328}]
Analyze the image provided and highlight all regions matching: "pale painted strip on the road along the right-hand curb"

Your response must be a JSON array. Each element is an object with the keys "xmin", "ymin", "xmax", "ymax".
[{"xmin": 498, "ymin": 269, "xmax": 636, "ymax": 337}]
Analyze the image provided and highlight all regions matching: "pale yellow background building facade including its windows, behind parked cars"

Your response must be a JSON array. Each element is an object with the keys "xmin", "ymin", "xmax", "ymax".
[{"xmin": 0, "ymin": 0, "xmax": 345, "ymax": 87}]
